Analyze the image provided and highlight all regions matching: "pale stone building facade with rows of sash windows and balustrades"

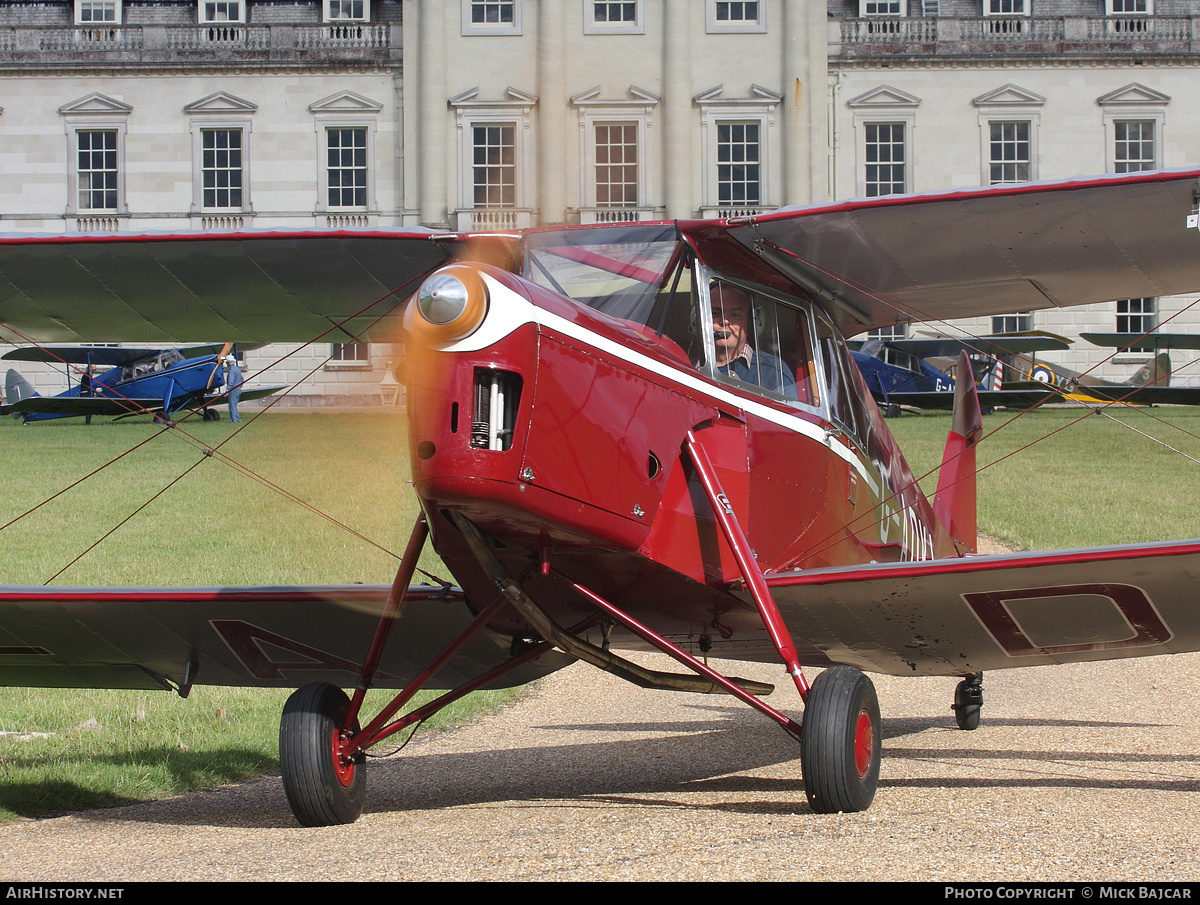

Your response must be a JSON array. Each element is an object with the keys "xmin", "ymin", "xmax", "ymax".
[{"xmin": 0, "ymin": 0, "xmax": 1200, "ymax": 402}]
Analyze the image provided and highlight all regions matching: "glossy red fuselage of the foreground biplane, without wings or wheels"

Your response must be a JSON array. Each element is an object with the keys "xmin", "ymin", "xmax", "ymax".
[{"xmin": 408, "ymin": 225, "xmax": 955, "ymax": 665}]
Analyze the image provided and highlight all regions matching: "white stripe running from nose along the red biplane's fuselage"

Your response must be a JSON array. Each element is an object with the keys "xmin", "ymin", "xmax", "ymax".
[{"xmin": 434, "ymin": 274, "xmax": 883, "ymax": 498}]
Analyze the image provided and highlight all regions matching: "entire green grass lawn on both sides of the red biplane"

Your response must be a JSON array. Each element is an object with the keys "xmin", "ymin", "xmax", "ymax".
[{"xmin": 0, "ymin": 400, "xmax": 1200, "ymax": 820}]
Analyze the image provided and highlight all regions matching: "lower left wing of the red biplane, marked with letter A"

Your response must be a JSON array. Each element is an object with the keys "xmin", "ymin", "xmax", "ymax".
[{"xmin": 0, "ymin": 585, "xmax": 570, "ymax": 688}]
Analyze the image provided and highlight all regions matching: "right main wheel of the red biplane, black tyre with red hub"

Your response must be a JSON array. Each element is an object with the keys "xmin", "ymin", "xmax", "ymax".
[{"xmin": 800, "ymin": 666, "xmax": 883, "ymax": 814}]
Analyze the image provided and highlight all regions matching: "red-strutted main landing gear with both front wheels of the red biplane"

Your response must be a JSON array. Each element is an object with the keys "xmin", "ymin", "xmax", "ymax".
[{"xmin": 280, "ymin": 433, "xmax": 897, "ymax": 826}]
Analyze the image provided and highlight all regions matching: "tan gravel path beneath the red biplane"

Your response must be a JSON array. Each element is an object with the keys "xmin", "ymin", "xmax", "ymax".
[{"xmin": 0, "ymin": 535, "xmax": 1200, "ymax": 883}]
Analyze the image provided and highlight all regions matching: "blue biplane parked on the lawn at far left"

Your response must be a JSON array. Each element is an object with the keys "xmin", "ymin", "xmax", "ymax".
[{"xmin": 0, "ymin": 343, "xmax": 286, "ymax": 424}]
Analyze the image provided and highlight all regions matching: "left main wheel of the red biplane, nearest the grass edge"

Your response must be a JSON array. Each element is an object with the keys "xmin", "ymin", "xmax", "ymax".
[{"xmin": 280, "ymin": 682, "xmax": 366, "ymax": 827}]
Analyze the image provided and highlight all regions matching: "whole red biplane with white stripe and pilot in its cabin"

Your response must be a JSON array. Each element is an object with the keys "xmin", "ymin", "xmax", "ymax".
[{"xmin": 0, "ymin": 170, "xmax": 1200, "ymax": 825}]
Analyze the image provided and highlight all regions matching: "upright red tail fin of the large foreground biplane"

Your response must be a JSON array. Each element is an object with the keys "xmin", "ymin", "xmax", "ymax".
[{"xmin": 934, "ymin": 352, "xmax": 983, "ymax": 553}]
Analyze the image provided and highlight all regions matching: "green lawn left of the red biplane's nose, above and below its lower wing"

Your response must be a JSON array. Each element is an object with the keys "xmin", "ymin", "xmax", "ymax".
[{"xmin": 0, "ymin": 413, "xmax": 514, "ymax": 820}]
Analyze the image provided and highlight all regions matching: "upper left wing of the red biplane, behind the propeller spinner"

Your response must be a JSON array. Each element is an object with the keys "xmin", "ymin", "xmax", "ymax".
[{"xmin": 0, "ymin": 229, "xmax": 450, "ymax": 343}]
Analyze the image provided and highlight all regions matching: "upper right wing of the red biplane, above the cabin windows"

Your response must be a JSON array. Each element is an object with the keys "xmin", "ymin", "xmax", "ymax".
[{"xmin": 701, "ymin": 170, "xmax": 1200, "ymax": 332}]
